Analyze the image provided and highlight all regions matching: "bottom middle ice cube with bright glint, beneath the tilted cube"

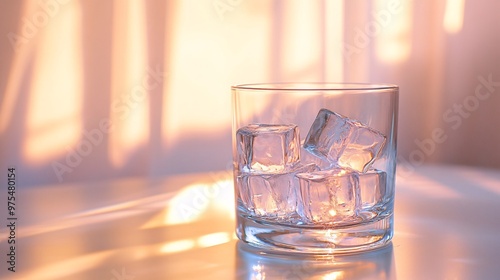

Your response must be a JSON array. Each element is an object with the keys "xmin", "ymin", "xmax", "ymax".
[{"xmin": 297, "ymin": 168, "xmax": 361, "ymax": 223}]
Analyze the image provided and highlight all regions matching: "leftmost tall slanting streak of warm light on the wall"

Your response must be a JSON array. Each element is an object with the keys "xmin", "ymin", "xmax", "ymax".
[{"xmin": 22, "ymin": 2, "xmax": 83, "ymax": 164}]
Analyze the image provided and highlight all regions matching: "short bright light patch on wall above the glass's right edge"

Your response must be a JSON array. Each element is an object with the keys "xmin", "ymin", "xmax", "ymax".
[{"xmin": 376, "ymin": 0, "xmax": 413, "ymax": 64}]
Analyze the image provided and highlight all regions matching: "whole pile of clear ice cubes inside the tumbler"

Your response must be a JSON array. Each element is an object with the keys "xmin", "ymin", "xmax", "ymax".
[{"xmin": 236, "ymin": 109, "xmax": 386, "ymax": 224}]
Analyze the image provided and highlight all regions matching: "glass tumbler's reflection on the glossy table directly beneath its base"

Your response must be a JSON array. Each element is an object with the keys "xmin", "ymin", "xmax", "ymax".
[{"xmin": 236, "ymin": 241, "xmax": 396, "ymax": 279}]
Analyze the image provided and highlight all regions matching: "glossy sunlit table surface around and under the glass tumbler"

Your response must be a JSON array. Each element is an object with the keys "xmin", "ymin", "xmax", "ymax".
[{"xmin": 0, "ymin": 166, "xmax": 500, "ymax": 280}]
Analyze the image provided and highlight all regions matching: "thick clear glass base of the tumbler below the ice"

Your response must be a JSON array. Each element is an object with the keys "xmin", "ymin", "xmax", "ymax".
[{"xmin": 236, "ymin": 212, "xmax": 393, "ymax": 255}]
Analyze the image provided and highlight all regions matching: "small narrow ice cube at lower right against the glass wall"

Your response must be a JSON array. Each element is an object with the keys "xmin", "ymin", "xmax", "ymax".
[{"xmin": 359, "ymin": 169, "xmax": 387, "ymax": 210}]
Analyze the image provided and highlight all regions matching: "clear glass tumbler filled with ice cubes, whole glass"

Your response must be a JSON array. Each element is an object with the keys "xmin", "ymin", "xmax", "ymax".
[{"xmin": 232, "ymin": 83, "xmax": 399, "ymax": 255}]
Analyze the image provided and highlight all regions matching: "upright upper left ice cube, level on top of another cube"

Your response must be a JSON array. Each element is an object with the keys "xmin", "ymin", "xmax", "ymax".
[{"xmin": 236, "ymin": 124, "xmax": 300, "ymax": 173}]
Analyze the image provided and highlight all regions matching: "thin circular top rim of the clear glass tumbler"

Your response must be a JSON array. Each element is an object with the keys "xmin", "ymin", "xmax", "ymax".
[{"xmin": 231, "ymin": 82, "xmax": 399, "ymax": 91}]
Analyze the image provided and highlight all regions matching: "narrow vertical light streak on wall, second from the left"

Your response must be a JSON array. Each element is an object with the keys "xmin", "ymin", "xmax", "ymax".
[{"xmin": 109, "ymin": 1, "xmax": 148, "ymax": 167}]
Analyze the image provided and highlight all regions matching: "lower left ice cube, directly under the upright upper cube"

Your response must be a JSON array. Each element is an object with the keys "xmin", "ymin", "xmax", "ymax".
[{"xmin": 237, "ymin": 164, "xmax": 318, "ymax": 218}]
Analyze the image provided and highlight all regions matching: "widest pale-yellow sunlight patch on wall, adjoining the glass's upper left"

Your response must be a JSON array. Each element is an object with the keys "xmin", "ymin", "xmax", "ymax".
[{"xmin": 162, "ymin": 0, "xmax": 271, "ymax": 149}]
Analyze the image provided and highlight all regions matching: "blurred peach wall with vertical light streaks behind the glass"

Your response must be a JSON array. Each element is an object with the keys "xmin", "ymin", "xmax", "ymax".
[{"xmin": 0, "ymin": 0, "xmax": 500, "ymax": 186}]
